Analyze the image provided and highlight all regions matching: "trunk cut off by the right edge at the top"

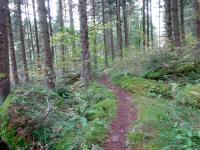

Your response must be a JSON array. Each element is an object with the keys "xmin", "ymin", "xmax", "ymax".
[{"xmin": 194, "ymin": 0, "xmax": 200, "ymax": 40}]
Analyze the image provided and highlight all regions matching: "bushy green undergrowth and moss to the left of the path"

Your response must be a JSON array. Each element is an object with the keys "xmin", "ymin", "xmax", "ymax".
[{"xmin": 0, "ymin": 83, "xmax": 117, "ymax": 150}]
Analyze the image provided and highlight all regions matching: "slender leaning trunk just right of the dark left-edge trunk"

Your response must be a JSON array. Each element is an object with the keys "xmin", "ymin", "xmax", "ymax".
[{"xmin": 8, "ymin": 11, "xmax": 19, "ymax": 84}]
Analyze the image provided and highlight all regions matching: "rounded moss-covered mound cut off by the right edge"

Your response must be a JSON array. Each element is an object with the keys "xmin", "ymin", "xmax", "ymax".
[{"xmin": 176, "ymin": 84, "xmax": 200, "ymax": 108}]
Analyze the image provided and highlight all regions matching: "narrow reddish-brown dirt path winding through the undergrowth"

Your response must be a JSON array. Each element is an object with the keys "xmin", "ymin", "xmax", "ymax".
[{"xmin": 100, "ymin": 75, "xmax": 137, "ymax": 150}]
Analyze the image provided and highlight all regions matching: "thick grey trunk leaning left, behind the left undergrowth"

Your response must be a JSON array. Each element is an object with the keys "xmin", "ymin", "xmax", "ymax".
[{"xmin": 37, "ymin": 0, "xmax": 55, "ymax": 89}]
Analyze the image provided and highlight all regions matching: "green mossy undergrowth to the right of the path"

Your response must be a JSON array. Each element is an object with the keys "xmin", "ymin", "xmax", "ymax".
[{"xmin": 111, "ymin": 73, "xmax": 200, "ymax": 150}]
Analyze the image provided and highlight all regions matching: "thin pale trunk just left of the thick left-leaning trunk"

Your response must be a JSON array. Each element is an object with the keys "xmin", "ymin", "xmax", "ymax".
[{"xmin": 32, "ymin": 0, "xmax": 41, "ymax": 70}]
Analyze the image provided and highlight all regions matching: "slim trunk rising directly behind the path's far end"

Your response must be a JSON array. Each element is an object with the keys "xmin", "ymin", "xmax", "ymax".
[{"xmin": 102, "ymin": 0, "xmax": 108, "ymax": 67}]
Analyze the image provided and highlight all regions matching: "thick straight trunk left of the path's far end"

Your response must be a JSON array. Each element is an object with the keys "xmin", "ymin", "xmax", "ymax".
[{"xmin": 79, "ymin": 0, "xmax": 90, "ymax": 86}]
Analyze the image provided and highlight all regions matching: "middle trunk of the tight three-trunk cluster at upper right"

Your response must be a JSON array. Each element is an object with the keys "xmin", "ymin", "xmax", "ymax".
[{"xmin": 171, "ymin": 0, "xmax": 181, "ymax": 47}]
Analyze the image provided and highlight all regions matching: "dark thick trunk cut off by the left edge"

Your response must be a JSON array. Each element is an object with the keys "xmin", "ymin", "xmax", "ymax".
[{"xmin": 0, "ymin": 0, "xmax": 10, "ymax": 103}]
